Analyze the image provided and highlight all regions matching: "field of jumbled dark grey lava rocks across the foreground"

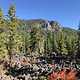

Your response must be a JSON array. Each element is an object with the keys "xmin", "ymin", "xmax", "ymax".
[{"xmin": 0, "ymin": 53, "xmax": 80, "ymax": 80}]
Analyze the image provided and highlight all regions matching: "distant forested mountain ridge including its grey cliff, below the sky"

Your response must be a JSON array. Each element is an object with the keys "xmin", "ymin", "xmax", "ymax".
[{"xmin": 12, "ymin": 19, "xmax": 78, "ymax": 35}]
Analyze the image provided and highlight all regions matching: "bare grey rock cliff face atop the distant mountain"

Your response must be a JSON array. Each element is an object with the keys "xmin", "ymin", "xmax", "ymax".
[{"xmin": 37, "ymin": 20, "xmax": 62, "ymax": 31}]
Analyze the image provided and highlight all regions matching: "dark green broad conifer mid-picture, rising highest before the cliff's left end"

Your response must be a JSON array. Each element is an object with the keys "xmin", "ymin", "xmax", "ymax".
[{"xmin": 30, "ymin": 25, "xmax": 40, "ymax": 52}]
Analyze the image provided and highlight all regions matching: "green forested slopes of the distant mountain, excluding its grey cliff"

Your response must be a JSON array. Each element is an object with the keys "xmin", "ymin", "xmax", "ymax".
[{"xmin": 17, "ymin": 19, "xmax": 78, "ymax": 36}]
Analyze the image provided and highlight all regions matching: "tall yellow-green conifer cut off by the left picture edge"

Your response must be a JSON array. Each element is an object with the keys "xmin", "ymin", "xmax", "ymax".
[{"xmin": 0, "ymin": 6, "xmax": 7, "ymax": 60}]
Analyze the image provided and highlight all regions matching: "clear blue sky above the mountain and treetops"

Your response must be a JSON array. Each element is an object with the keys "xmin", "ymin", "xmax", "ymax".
[{"xmin": 0, "ymin": 0, "xmax": 80, "ymax": 30}]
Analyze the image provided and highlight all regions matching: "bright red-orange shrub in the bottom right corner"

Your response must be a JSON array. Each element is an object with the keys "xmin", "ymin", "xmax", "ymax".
[{"xmin": 48, "ymin": 68, "xmax": 78, "ymax": 80}]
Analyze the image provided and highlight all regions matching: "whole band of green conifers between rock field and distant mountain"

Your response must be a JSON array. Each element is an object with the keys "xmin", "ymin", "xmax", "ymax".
[{"xmin": 0, "ymin": 3, "xmax": 80, "ymax": 60}]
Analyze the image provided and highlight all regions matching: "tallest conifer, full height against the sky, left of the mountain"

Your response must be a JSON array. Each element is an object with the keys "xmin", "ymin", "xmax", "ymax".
[{"xmin": 6, "ymin": 2, "xmax": 19, "ymax": 59}]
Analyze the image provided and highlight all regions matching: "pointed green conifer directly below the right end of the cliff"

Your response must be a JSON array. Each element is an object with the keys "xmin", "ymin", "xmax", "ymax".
[{"xmin": 59, "ymin": 32, "xmax": 68, "ymax": 55}]
